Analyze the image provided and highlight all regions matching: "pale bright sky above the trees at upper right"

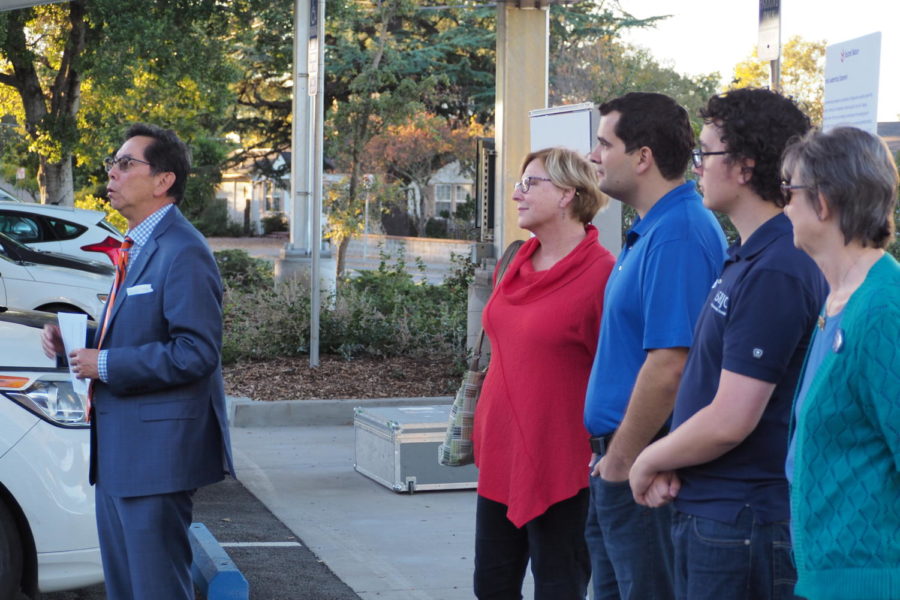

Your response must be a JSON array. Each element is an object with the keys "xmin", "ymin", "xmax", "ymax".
[{"xmin": 619, "ymin": 0, "xmax": 900, "ymax": 121}]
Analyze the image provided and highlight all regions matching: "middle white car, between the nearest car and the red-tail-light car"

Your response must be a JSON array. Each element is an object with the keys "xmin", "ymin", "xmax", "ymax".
[{"xmin": 0, "ymin": 234, "xmax": 115, "ymax": 322}]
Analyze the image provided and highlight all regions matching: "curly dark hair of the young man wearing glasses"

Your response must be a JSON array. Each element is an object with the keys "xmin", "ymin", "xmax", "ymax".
[{"xmin": 700, "ymin": 88, "xmax": 811, "ymax": 207}]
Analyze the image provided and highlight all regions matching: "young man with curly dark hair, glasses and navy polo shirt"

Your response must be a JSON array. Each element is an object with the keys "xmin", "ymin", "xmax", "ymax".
[{"xmin": 630, "ymin": 89, "xmax": 826, "ymax": 600}]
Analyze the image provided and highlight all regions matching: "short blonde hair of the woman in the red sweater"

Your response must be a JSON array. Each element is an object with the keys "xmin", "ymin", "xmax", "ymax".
[{"xmin": 520, "ymin": 147, "xmax": 609, "ymax": 223}]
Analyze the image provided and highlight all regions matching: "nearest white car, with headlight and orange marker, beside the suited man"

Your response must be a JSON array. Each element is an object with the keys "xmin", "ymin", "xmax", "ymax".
[{"xmin": 0, "ymin": 307, "xmax": 103, "ymax": 599}]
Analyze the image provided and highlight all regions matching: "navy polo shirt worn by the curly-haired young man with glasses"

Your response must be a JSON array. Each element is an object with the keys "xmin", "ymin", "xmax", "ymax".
[{"xmin": 672, "ymin": 214, "xmax": 828, "ymax": 523}]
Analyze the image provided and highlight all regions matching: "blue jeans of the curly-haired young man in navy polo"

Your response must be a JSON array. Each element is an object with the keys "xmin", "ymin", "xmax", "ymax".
[{"xmin": 672, "ymin": 507, "xmax": 797, "ymax": 600}]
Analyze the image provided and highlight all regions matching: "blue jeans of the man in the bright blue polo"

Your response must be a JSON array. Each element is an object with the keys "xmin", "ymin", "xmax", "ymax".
[{"xmin": 584, "ymin": 468, "xmax": 674, "ymax": 600}]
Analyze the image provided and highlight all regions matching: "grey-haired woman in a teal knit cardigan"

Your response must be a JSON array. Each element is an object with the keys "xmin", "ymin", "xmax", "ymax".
[{"xmin": 782, "ymin": 128, "xmax": 900, "ymax": 600}]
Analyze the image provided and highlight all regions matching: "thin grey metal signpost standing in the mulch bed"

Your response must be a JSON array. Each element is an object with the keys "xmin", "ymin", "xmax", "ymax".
[{"xmin": 309, "ymin": 0, "xmax": 325, "ymax": 367}]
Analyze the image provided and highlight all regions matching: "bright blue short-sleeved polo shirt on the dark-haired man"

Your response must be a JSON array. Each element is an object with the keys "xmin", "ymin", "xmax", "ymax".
[{"xmin": 584, "ymin": 181, "xmax": 726, "ymax": 435}]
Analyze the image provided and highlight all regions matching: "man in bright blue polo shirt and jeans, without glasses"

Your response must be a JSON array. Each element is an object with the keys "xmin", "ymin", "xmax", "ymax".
[{"xmin": 584, "ymin": 93, "xmax": 725, "ymax": 600}]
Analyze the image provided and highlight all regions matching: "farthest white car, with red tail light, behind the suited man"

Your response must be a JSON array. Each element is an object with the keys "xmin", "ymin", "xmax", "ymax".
[{"xmin": 0, "ymin": 201, "xmax": 125, "ymax": 264}]
